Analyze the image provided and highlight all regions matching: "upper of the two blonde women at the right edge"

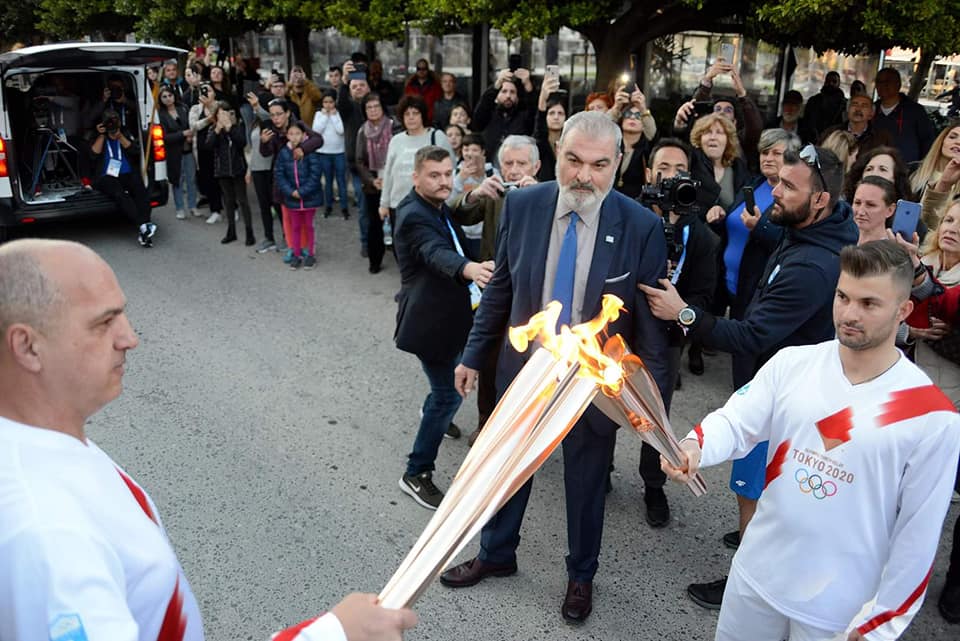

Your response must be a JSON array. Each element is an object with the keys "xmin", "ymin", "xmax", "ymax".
[{"xmin": 910, "ymin": 122, "xmax": 960, "ymax": 229}]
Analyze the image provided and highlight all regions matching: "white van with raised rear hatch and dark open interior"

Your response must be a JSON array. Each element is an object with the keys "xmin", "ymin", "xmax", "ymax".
[{"xmin": 0, "ymin": 42, "xmax": 185, "ymax": 242}]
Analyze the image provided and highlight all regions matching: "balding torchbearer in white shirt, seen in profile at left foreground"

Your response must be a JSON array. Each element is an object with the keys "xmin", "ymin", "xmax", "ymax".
[{"xmin": 0, "ymin": 240, "xmax": 416, "ymax": 641}]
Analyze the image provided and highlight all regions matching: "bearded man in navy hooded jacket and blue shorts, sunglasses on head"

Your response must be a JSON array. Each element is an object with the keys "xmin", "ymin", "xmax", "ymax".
[{"xmin": 639, "ymin": 145, "xmax": 858, "ymax": 609}]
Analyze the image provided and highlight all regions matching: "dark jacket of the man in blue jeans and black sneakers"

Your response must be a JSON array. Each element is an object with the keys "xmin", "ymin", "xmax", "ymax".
[{"xmin": 394, "ymin": 189, "xmax": 473, "ymax": 361}]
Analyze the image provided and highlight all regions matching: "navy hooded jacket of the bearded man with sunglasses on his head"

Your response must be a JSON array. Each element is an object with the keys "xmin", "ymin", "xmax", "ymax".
[{"xmin": 691, "ymin": 200, "xmax": 858, "ymax": 380}]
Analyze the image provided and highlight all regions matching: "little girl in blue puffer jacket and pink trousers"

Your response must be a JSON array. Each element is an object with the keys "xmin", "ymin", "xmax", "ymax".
[{"xmin": 274, "ymin": 121, "xmax": 323, "ymax": 269}]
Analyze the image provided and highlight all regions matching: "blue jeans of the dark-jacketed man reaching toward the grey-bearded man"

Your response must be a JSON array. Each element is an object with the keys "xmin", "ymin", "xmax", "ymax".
[{"xmin": 407, "ymin": 354, "xmax": 463, "ymax": 476}]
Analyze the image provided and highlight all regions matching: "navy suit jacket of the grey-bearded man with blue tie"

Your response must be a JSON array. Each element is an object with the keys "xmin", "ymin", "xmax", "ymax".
[{"xmin": 463, "ymin": 182, "xmax": 673, "ymax": 432}]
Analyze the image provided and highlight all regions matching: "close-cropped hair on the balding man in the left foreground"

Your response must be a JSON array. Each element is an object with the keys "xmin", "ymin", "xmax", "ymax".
[{"xmin": 0, "ymin": 240, "xmax": 66, "ymax": 335}]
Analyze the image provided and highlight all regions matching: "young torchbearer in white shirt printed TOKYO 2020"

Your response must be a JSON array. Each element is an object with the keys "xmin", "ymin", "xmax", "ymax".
[{"xmin": 662, "ymin": 240, "xmax": 960, "ymax": 641}]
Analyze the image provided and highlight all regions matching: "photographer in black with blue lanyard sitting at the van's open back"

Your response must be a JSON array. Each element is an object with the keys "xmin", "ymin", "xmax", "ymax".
[{"xmin": 90, "ymin": 109, "xmax": 157, "ymax": 247}]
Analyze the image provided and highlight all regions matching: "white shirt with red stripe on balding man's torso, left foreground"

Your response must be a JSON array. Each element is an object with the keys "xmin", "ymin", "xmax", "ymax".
[{"xmin": 0, "ymin": 418, "xmax": 203, "ymax": 641}]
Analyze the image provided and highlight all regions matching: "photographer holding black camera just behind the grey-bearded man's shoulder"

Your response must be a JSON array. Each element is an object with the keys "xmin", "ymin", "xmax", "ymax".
[{"xmin": 639, "ymin": 138, "xmax": 720, "ymax": 528}]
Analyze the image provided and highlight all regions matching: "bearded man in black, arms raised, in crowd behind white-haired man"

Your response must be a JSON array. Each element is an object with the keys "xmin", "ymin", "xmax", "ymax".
[{"xmin": 470, "ymin": 69, "xmax": 536, "ymax": 158}]
